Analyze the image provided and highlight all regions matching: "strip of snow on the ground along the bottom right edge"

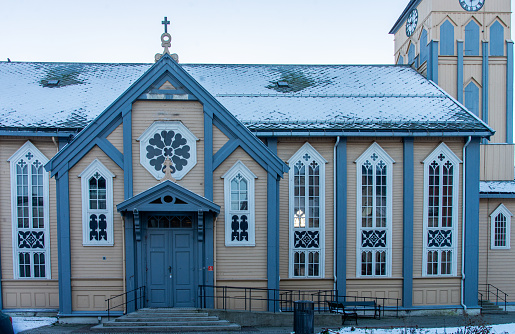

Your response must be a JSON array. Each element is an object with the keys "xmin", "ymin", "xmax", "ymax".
[{"xmin": 329, "ymin": 323, "xmax": 515, "ymax": 334}]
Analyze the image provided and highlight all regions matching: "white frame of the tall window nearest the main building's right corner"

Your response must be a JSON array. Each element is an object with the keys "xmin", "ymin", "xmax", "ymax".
[{"xmin": 422, "ymin": 143, "xmax": 462, "ymax": 277}]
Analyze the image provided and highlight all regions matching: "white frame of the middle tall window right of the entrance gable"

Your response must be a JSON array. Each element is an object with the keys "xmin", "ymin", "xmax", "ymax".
[{"xmin": 355, "ymin": 142, "xmax": 395, "ymax": 277}]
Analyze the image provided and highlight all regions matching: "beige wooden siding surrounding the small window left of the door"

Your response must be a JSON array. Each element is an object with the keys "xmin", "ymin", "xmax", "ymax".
[{"xmin": 69, "ymin": 146, "xmax": 124, "ymax": 311}]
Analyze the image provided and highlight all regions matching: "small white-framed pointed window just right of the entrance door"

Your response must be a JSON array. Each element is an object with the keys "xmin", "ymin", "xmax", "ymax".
[{"xmin": 222, "ymin": 161, "xmax": 257, "ymax": 246}]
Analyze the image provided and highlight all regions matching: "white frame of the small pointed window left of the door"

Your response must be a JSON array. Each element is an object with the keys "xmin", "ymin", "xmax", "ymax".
[{"xmin": 79, "ymin": 159, "xmax": 115, "ymax": 246}]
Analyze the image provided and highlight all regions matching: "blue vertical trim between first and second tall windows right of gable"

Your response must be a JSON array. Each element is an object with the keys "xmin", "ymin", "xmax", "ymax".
[{"xmin": 334, "ymin": 137, "xmax": 347, "ymax": 296}]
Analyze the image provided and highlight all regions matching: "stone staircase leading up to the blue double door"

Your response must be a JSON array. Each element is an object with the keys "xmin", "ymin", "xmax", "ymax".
[{"xmin": 91, "ymin": 308, "xmax": 241, "ymax": 333}]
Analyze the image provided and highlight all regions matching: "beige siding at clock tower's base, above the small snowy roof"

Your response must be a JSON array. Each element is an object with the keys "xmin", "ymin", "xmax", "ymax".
[{"xmin": 480, "ymin": 144, "xmax": 515, "ymax": 181}]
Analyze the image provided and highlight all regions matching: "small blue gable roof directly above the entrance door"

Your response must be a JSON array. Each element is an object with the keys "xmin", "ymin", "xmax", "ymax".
[{"xmin": 116, "ymin": 180, "xmax": 220, "ymax": 214}]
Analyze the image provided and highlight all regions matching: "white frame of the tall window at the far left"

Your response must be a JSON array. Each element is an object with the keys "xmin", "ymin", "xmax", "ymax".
[{"xmin": 7, "ymin": 141, "xmax": 52, "ymax": 280}]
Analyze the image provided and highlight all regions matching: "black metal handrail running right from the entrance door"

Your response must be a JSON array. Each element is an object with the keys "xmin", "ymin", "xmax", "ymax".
[{"xmin": 198, "ymin": 285, "xmax": 400, "ymax": 317}]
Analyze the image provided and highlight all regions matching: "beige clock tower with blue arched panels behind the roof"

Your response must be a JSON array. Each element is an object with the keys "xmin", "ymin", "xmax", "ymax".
[{"xmin": 390, "ymin": 0, "xmax": 514, "ymax": 181}]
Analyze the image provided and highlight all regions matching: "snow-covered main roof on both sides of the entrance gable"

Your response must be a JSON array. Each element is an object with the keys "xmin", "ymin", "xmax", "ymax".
[{"xmin": 0, "ymin": 62, "xmax": 492, "ymax": 135}]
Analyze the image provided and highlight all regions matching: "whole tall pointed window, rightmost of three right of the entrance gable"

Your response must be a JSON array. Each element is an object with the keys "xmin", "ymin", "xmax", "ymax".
[{"xmin": 423, "ymin": 143, "xmax": 461, "ymax": 276}]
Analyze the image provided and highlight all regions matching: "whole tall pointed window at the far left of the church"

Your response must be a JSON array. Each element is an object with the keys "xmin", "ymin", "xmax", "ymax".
[{"xmin": 8, "ymin": 142, "xmax": 50, "ymax": 279}]
